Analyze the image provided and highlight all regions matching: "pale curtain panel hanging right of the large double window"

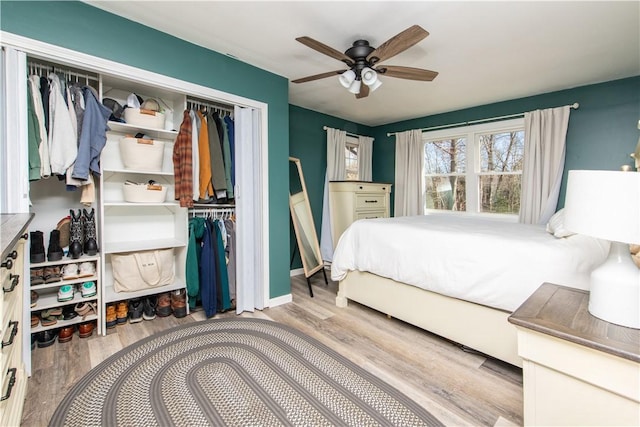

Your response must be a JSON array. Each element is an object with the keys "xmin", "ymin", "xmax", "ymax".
[{"xmin": 519, "ymin": 105, "xmax": 570, "ymax": 224}]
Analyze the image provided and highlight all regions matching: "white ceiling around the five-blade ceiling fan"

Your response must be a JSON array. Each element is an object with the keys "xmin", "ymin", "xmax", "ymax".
[{"xmin": 86, "ymin": 1, "xmax": 640, "ymax": 126}]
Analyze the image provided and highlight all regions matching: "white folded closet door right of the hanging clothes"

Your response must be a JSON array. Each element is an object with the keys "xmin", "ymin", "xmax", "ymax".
[{"xmin": 234, "ymin": 106, "xmax": 268, "ymax": 314}]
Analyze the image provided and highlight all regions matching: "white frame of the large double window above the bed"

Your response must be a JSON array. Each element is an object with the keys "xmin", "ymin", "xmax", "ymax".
[{"xmin": 421, "ymin": 117, "xmax": 525, "ymax": 222}]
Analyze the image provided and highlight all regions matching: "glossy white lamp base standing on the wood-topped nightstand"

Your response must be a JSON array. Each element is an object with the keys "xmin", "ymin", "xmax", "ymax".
[{"xmin": 589, "ymin": 242, "xmax": 640, "ymax": 329}]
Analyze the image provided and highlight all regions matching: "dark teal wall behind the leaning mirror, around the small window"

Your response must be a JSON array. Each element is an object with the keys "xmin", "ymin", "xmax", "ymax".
[{"xmin": 289, "ymin": 105, "xmax": 373, "ymax": 268}]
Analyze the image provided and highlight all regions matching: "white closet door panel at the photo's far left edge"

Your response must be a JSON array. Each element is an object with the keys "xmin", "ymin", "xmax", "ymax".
[{"xmin": 0, "ymin": 47, "xmax": 29, "ymax": 213}]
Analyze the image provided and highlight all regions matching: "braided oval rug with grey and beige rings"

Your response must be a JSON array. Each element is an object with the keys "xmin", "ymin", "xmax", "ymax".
[{"xmin": 49, "ymin": 318, "xmax": 442, "ymax": 426}]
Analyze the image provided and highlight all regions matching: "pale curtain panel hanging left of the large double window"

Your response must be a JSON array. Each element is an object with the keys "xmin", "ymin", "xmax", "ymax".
[{"xmin": 394, "ymin": 129, "xmax": 424, "ymax": 216}]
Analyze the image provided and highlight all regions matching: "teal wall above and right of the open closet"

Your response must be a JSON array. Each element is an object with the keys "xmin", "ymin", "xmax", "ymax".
[{"xmin": 0, "ymin": 0, "xmax": 290, "ymax": 298}]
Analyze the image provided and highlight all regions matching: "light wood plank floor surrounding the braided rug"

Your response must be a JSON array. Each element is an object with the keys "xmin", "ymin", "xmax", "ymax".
[{"xmin": 22, "ymin": 275, "xmax": 522, "ymax": 427}]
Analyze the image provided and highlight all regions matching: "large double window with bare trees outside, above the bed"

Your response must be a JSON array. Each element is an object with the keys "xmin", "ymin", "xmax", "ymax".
[{"xmin": 423, "ymin": 119, "xmax": 524, "ymax": 215}]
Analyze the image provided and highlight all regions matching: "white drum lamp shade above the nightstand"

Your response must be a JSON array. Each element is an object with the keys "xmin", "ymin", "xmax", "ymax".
[{"xmin": 565, "ymin": 170, "xmax": 640, "ymax": 244}]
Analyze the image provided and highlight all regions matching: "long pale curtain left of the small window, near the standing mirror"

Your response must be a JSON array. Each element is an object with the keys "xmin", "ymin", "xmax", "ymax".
[{"xmin": 320, "ymin": 128, "xmax": 347, "ymax": 262}]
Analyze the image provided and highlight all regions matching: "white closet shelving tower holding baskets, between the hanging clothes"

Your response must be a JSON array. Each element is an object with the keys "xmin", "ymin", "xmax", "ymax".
[{"xmin": 99, "ymin": 76, "xmax": 188, "ymax": 334}]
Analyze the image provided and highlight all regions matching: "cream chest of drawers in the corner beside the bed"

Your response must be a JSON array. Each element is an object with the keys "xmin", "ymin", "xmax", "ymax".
[{"xmin": 329, "ymin": 181, "xmax": 391, "ymax": 248}]
